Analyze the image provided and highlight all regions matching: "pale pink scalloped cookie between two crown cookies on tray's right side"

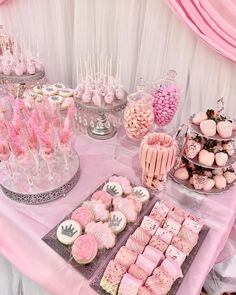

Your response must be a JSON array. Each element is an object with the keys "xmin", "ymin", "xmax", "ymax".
[{"xmin": 113, "ymin": 197, "xmax": 138, "ymax": 222}]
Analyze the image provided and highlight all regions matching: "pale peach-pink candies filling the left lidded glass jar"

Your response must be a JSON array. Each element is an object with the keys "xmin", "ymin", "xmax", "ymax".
[{"xmin": 124, "ymin": 100, "xmax": 153, "ymax": 139}]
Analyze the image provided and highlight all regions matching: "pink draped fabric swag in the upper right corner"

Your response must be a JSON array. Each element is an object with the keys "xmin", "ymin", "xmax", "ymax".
[{"xmin": 166, "ymin": 0, "xmax": 236, "ymax": 62}]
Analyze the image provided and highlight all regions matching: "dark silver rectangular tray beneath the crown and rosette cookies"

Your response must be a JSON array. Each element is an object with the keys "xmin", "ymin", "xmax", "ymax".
[{"xmin": 42, "ymin": 180, "xmax": 157, "ymax": 279}]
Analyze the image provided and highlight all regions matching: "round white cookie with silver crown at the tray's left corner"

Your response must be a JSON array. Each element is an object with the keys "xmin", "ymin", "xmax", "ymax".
[{"xmin": 57, "ymin": 219, "xmax": 82, "ymax": 245}]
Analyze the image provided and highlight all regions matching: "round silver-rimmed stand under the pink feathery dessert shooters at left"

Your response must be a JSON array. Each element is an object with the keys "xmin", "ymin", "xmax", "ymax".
[{"xmin": 1, "ymin": 152, "xmax": 80, "ymax": 205}]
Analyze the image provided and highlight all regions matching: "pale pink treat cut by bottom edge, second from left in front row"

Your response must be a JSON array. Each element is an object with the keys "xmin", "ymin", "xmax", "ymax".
[{"xmin": 118, "ymin": 273, "xmax": 143, "ymax": 295}]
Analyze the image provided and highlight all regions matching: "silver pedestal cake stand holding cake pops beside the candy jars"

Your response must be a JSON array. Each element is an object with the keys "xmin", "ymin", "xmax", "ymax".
[{"xmin": 76, "ymin": 97, "xmax": 127, "ymax": 140}]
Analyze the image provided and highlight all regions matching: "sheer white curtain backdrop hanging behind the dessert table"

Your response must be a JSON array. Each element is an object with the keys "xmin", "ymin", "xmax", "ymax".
[{"xmin": 0, "ymin": 0, "xmax": 236, "ymax": 295}]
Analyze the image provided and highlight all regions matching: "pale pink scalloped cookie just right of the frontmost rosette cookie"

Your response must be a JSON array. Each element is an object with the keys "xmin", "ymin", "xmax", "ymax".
[{"xmin": 85, "ymin": 222, "xmax": 116, "ymax": 249}]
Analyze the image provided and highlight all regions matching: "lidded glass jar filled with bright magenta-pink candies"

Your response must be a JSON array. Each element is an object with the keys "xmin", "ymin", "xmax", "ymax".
[{"xmin": 152, "ymin": 70, "xmax": 180, "ymax": 126}]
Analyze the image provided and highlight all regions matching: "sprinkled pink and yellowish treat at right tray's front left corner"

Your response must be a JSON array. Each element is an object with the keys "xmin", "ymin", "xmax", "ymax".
[{"xmin": 100, "ymin": 260, "xmax": 126, "ymax": 295}]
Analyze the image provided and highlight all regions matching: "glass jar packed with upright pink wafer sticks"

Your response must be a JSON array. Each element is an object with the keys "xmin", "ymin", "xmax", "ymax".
[{"xmin": 139, "ymin": 133, "xmax": 177, "ymax": 190}]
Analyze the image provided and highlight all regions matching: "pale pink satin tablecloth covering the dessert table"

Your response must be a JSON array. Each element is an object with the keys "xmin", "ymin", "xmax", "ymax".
[{"xmin": 0, "ymin": 135, "xmax": 236, "ymax": 295}]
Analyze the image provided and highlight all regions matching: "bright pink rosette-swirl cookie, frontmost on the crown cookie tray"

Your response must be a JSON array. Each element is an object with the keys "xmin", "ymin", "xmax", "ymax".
[{"xmin": 72, "ymin": 234, "xmax": 98, "ymax": 264}]
